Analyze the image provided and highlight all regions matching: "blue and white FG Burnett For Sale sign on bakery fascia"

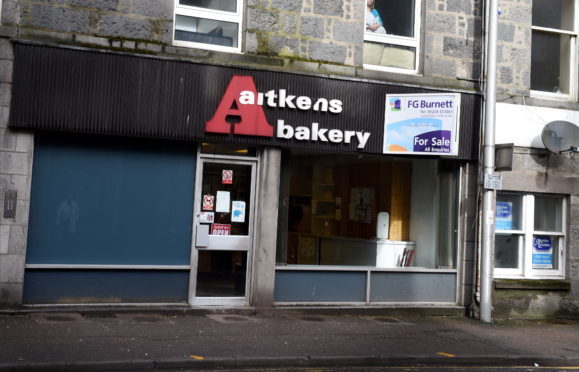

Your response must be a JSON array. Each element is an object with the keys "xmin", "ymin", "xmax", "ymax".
[{"xmin": 382, "ymin": 93, "xmax": 460, "ymax": 155}]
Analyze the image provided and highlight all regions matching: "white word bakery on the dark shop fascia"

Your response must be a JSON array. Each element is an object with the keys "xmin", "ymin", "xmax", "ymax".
[{"xmin": 276, "ymin": 120, "xmax": 370, "ymax": 149}]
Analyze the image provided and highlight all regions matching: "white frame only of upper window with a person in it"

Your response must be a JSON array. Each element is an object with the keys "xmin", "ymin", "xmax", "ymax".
[{"xmin": 363, "ymin": 0, "xmax": 422, "ymax": 74}]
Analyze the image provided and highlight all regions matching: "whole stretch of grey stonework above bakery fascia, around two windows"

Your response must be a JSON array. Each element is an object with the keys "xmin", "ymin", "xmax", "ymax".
[{"xmin": 0, "ymin": 0, "xmax": 482, "ymax": 90}]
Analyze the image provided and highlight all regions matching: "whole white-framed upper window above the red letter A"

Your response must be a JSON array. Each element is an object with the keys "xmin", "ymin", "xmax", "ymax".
[{"xmin": 173, "ymin": 0, "xmax": 243, "ymax": 52}]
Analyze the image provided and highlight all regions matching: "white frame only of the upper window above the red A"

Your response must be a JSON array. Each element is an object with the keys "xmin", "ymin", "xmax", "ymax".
[{"xmin": 172, "ymin": 0, "xmax": 244, "ymax": 53}]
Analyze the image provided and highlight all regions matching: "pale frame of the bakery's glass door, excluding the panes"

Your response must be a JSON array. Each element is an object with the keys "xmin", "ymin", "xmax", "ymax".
[{"xmin": 188, "ymin": 148, "xmax": 260, "ymax": 307}]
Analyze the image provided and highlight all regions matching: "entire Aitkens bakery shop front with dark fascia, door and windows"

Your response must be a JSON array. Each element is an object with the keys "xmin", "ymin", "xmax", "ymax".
[{"xmin": 10, "ymin": 43, "xmax": 480, "ymax": 307}]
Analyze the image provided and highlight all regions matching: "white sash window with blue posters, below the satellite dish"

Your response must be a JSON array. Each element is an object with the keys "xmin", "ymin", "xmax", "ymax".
[{"xmin": 494, "ymin": 193, "xmax": 565, "ymax": 279}]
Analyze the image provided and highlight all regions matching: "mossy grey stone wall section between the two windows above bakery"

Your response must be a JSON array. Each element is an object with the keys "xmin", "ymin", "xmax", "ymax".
[{"xmin": 246, "ymin": 0, "xmax": 365, "ymax": 66}]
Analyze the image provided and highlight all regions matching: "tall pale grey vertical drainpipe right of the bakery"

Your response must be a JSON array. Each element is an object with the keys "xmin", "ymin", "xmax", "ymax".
[{"xmin": 480, "ymin": 0, "xmax": 498, "ymax": 323}]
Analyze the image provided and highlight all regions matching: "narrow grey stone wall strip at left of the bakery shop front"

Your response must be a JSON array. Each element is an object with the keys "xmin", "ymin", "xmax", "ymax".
[{"xmin": 0, "ymin": 38, "xmax": 34, "ymax": 307}]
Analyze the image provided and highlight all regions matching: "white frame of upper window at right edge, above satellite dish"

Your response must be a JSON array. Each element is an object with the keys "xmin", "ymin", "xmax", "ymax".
[{"xmin": 531, "ymin": 0, "xmax": 579, "ymax": 101}]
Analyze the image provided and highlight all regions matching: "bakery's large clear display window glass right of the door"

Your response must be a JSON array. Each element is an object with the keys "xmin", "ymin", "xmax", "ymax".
[{"xmin": 277, "ymin": 153, "xmax": 458, "ymax": 269}]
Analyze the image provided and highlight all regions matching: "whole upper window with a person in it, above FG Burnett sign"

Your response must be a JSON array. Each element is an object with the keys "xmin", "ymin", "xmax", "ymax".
[{"xmin": 364, "ymin": 0, "xmax": 421, "ymax": 72}]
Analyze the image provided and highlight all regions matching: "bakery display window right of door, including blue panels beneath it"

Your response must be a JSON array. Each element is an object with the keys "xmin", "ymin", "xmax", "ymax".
[{"xmin": 275, "ymin": 153, "xmax": 461, "ymax": 304}]
